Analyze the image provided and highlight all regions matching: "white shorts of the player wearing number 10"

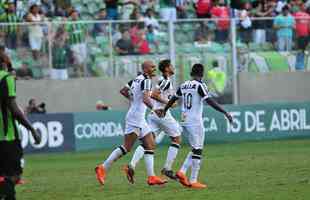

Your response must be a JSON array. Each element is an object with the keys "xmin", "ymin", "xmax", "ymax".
[{"xmin": 183, "ymin": 125, "xmax": 205, "ymax": 149}]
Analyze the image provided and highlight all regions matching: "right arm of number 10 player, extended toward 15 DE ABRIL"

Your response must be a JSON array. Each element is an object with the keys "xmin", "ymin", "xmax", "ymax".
[{"xmin": 198, "ymin": 83, "xmax": 233, "ymax": 123}]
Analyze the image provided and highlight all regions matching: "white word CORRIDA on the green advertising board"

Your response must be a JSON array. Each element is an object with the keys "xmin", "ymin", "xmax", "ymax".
[{"xmin": 74, "ymin": 122, "xmax": 124, "ymax": 139}]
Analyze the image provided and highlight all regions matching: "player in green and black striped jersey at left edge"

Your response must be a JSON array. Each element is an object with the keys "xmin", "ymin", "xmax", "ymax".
[{"xmin": 0, "ymin": 54, "xmax": 41, "ymax": 200}]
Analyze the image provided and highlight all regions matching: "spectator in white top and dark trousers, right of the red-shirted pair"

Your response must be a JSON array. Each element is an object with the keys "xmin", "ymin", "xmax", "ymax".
[{"xmin": 239, "ymin": 2, "xmax": 252, "ymax": 44}]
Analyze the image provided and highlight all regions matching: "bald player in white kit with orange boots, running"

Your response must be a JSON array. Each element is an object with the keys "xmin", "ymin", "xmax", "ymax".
[{"xmin": 96, "ymin": 61, "xmax": 167, "ymax": 185}]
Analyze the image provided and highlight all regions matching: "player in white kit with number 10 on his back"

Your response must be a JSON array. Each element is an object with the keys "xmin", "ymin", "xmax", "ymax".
[{"xmin": 159, "ymin": 64, "xmax": 232, "ymax": 189}]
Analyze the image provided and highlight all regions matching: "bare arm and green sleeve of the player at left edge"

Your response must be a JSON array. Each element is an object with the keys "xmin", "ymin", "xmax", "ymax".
[{"xmin": 6, "ymin": 76, "xmax": 41, "ymax": 144}]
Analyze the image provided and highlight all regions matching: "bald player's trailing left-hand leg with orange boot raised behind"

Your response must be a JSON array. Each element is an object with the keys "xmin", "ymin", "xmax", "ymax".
[{"xmin": 95, "ymin": 126, "xmax": 139, "ymax": 185}]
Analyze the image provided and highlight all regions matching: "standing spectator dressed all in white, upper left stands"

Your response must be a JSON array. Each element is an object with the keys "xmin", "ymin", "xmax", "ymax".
[{"xmin": 27, "ymin": 4, "xmax": 44, "ymax": 60}]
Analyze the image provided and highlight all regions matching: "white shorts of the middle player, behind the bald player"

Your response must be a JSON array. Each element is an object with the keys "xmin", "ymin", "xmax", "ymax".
[{"xmin": 147, "ymin": 112, "xmax": 182, "ymax": 137}]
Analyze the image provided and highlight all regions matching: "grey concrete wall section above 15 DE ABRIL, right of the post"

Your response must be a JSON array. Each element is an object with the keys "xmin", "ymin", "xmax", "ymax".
[{"xmin": 238, "ymin": 72, "xmax": 310, "ymax": 104}]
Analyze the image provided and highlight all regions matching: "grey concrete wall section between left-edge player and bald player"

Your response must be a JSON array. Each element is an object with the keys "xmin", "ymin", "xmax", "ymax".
[{"xmin": 17, "ymin": 78, "xmax": 128, "ymax": 112}]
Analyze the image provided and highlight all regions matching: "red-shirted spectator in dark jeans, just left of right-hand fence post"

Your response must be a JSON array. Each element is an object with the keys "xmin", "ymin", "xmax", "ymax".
[{"xmin": 210, "ymin": 0, "xmax": 230, "ymax": 43}]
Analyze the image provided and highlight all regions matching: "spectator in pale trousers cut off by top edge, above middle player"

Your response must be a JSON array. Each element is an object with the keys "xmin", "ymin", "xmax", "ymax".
[{"xmin": 159, "ymin": 0, "xmax": 177, "ymax": 21}]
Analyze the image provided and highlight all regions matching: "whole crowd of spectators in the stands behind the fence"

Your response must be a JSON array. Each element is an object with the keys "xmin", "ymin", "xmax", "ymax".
[{"xmin": 0, "ymin": 0, "xmax": 310, "ymax": 79}]
